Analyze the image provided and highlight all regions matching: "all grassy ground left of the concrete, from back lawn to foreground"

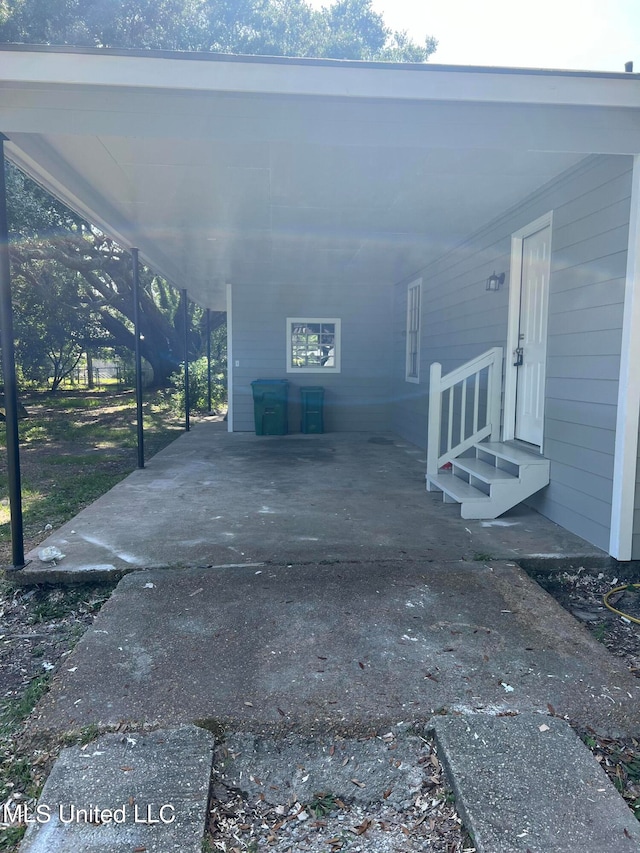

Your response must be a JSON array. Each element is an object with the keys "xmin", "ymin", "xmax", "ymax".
[{"xmin": 0, "ymin": 390, "xmax": 184, "ymax": 853}]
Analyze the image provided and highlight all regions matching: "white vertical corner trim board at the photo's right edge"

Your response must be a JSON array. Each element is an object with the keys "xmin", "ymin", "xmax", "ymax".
[{"xmin": 609, "ymin": 155, "xmax": 640, "ymax": 560}]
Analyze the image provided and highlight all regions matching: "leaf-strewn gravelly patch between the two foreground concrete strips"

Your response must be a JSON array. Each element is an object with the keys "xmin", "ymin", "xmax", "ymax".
[{"xmin": 208, "ymin": 732, "xmax": 473, "ymax": 853}]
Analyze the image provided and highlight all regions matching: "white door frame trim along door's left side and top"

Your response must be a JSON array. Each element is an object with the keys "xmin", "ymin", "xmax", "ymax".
[{"xmin": 502, "ymin": 210, "xmax": 553, "ymax": 446}]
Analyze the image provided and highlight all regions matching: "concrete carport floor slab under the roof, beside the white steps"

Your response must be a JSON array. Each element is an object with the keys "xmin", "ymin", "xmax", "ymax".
[{"xmin": 22, "ymin": 422, "xmax": 607, "ymax": 580}]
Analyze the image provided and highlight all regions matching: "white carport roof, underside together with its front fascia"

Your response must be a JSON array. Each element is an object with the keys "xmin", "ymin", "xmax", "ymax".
[{"xmin": 0, "ymin": 46, "xmax": 640, "ymax": 309}]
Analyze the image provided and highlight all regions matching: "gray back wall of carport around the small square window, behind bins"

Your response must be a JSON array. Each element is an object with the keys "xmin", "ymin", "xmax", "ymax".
[{"xmin": 230, "ymin": 282, "xmax": 392, "ymax": 432}]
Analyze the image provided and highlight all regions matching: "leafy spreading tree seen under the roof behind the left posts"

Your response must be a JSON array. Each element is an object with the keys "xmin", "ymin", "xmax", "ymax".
[{"xmin": 7, "ymin": 164, "xmax": 225, "ymax": 387}]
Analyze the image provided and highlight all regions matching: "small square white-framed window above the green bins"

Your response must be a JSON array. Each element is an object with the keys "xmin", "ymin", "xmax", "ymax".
[{"xmin": 287, "ymin": 317, "xmax": 340, "ymax": 373}]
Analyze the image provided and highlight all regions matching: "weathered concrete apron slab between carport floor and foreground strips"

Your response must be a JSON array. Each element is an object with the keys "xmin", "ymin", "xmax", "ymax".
[{"xmin": 32, "ymin": 560, "xmax": 640, "ymax": 735}]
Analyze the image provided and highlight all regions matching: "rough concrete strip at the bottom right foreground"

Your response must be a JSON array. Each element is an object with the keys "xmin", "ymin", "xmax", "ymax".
[{"xmin": 434, "ymin": 713, "xmax": 640, "ymax": 853}]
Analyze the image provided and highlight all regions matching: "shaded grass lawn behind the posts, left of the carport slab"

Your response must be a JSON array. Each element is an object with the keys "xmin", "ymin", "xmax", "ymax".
[{"xmin": 0, "ymin": 390, "xmax": 183, "ymax": 565}]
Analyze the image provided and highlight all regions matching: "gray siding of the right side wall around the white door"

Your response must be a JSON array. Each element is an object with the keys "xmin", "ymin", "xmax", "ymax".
[{"xmin": 393, "ymin": 156, "xmax": 640, "ymax": 554}]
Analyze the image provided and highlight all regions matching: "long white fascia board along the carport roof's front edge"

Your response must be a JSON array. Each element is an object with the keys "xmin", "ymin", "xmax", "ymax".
[{"xmin": 0, "ymin": 46, "xmax": 640, "ymax": 108}]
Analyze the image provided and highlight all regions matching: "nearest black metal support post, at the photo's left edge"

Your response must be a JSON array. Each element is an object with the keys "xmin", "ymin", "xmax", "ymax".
[{"xmin": 0, "ymin": 133, "xmax": 26, "ymax": 569}]
